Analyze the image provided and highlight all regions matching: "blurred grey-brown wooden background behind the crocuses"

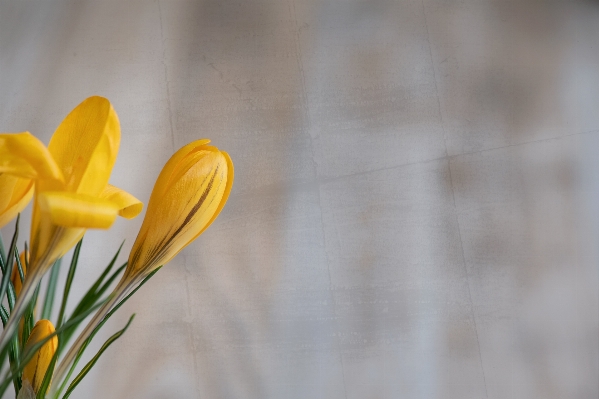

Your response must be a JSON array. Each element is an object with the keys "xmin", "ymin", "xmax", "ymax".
[{"xmin": 0, "ymin": 0, "xmax": 599, "ymax": 399}]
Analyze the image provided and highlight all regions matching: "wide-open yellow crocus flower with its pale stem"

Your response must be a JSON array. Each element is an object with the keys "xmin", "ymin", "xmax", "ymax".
[{"xmin": 0, "ymin": 96, "xmax": 142, "ymax": 348}]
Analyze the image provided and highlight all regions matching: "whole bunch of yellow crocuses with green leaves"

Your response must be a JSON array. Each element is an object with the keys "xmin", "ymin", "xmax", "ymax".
[{"xmin": 0, "ymin": 97, "xmax": 233, "ymax": 399}]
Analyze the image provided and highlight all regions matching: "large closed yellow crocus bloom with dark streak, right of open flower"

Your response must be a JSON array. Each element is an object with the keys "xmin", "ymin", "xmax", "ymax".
[{"xmin": 125, "ymin": 140, "xmax": 233, "ymax": 278}]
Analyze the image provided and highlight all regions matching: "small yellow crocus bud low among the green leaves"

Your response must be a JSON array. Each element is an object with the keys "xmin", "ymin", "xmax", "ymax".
[{"xmin": 22, "ymin": 319, "xmax": 58, "ymax": 393}]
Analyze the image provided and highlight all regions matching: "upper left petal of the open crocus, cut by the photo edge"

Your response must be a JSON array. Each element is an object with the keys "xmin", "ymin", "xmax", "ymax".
[{"xmin": 0, "ymin": 132, "xmax": 63, "ymax": 181}]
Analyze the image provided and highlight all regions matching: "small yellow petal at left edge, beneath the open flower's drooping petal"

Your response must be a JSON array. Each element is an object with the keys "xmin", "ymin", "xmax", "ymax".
[{"xmin": 0, "ymin": 173, "xmax": 33, "ymax": 228}]
